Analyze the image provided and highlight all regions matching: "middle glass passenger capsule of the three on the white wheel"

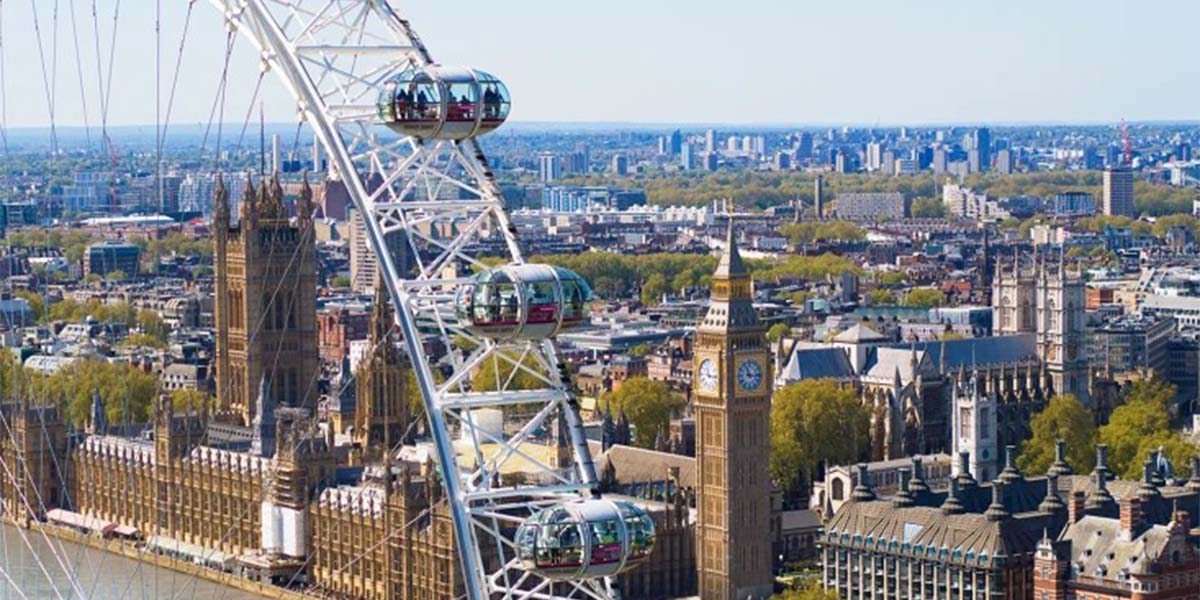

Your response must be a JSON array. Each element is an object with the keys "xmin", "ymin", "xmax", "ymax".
[{"xmin": 456, "ymin": 264, "xmax": 592, "ymax": 340}]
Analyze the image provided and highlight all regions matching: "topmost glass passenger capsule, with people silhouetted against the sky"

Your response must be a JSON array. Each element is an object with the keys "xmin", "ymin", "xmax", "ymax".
[{"xmin": 378, "ymin": 65, "xmax": 512, "ymax": 139}]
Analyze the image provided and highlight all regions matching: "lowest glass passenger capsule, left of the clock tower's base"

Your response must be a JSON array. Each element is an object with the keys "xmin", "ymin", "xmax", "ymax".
[{"xmin": 515, "ymin": 499, "xmax": 654, "ymax": 580}]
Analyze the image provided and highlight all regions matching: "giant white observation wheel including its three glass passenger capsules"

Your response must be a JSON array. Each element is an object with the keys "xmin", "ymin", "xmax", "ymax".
[{"xmin": 210, "ymin": 0, "xmax": 654, "ymax": 600}]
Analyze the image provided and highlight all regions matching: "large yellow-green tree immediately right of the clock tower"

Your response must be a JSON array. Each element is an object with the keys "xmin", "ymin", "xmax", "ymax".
[{"xmin": 769, "ymin": 379, "xmax": 871, "ymax": 492}]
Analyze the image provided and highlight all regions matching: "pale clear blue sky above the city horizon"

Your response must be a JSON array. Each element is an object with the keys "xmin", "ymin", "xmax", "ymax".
[{"xmin": 2, "ymin": 0, "xmax": 1200, "ymax": 126}]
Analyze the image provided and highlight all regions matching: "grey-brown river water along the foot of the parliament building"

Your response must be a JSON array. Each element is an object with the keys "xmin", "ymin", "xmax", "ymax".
[{"xmin": 0, "ymin": 524, "xmax": 263, "ymax": 600}]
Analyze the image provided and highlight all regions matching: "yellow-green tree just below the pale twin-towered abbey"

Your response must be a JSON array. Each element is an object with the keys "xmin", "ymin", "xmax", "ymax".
[{"xmin": 1016, "ymin": 394, "xmax": 1096, "ymax": 473}]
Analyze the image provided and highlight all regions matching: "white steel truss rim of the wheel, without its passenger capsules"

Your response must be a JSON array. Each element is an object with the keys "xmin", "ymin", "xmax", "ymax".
[{"xmin": 210, "ymin": 0, "xmax": 612, "ymax": 600}]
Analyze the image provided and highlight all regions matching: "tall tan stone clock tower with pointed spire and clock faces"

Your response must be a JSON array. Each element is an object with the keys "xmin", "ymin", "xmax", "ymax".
[{"xmin": 694, "ymin": 222, "xmax": 773, "ymax": 600}]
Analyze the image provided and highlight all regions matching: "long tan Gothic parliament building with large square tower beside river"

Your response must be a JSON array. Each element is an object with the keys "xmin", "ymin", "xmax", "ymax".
[{"xmin": 0, "ymin": 179, "xmax": 461, "ymax": 600}]
